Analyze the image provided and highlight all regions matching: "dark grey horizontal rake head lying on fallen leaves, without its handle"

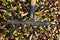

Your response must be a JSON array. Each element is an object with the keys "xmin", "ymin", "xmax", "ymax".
[{"xmin": 6, "ymin": 20, "xmax": 58, "ymax": 26}]
